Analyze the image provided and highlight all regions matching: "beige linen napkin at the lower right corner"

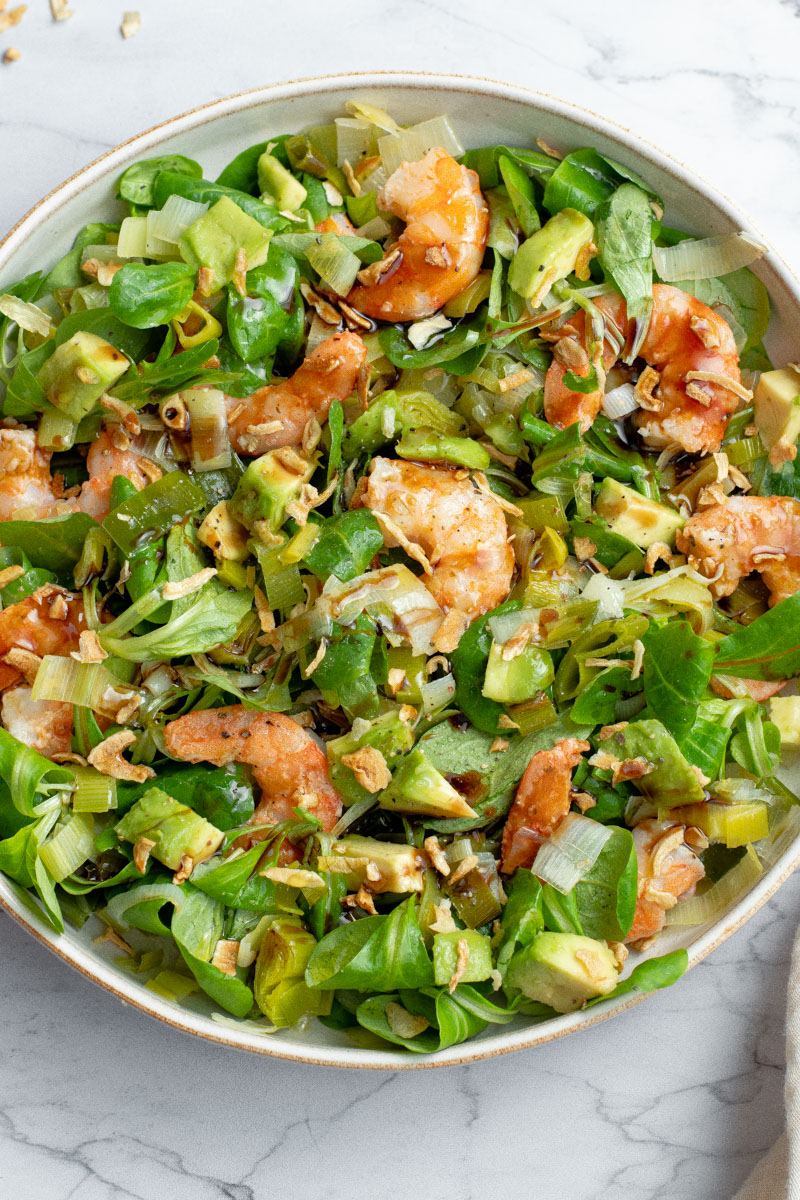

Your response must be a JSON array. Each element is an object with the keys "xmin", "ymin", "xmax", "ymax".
[{"xmin": 734, "ymin": 934, "xmax": 800, "ymax": 1200}]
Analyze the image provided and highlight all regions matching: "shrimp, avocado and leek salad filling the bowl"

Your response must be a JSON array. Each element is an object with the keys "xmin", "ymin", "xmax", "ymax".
[{"xmin": 0, "ymin": 102, "xmax": 800, "ymax": 1054}]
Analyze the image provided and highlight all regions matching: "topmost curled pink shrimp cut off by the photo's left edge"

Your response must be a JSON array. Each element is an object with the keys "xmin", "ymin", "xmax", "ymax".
[{"xmin": 0, "ymin": 428, "xmax": 161, "ymax": 521}]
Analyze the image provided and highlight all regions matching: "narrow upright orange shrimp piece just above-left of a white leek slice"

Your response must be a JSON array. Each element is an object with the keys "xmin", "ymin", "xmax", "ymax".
[{"xmin": 503, "ymin": 738, "xmax": 590, "ymax": 875}]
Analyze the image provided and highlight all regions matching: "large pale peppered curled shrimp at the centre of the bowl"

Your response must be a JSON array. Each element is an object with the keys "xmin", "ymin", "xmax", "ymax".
[{"xmin": 351, "ymin": 458, "xmax": 515, "ymax": 620}]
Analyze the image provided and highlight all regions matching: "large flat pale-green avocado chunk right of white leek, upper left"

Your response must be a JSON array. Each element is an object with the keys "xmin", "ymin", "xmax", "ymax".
[{"xmin": 178, "ymin": 196, "xmax": 272, "ymax": 293}]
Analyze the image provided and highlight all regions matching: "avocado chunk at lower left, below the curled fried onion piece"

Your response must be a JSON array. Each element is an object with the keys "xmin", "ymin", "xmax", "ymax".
[{"xmin": 115, "ymin": 787, "xmax": 224, "ymax": 871}]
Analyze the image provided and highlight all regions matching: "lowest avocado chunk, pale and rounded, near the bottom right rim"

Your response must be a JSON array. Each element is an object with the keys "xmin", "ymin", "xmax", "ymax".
[{"xmin": 505, "ymin": 934, "xmax": 619, "ymax": 1013}]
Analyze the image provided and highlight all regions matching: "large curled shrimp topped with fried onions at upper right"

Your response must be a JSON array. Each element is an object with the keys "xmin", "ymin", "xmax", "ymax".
[{"xmin": 545, "ymin": 283, "xmax": 747, "ymax": 454}]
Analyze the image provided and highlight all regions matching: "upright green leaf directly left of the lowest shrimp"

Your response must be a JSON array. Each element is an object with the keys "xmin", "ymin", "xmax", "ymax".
[{"xmin": 575, "ymin": 826, "xmax": 638, "ymax": 942}]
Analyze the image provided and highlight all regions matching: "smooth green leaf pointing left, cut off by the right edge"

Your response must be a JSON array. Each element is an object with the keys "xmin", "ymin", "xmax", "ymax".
[{"xmin": 714, "ymin": 595, "xmax": 800, "ymax": 679}]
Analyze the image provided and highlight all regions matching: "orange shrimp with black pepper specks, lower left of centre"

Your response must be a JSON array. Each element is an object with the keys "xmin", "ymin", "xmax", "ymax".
[{"xmin": 164, "ymin": 704, "xmax": 342, "ymax": 830}]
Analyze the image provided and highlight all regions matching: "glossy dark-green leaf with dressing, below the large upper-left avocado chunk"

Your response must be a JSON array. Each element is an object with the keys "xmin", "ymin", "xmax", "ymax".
[{"xmin": 227, "ymin": 244, "xmax": 299, "ymax": 362}]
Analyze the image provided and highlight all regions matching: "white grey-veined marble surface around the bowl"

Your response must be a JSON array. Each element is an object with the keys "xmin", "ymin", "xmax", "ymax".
[{"xmin": 0, "ymin": 0, "xmax": 800, "ymax": 1200}]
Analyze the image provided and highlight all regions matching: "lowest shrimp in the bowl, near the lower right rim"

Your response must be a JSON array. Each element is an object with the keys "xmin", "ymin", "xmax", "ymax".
[{"xmin": 625, "ymin": 821, "xmax": 705, "ymax": 942}]
